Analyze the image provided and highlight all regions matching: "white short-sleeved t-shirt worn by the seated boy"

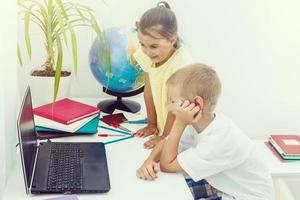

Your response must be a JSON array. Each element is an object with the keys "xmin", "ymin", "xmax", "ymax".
[{"xmin": 177, "ymin": 113, "xmax": 274, "ymax": 200}]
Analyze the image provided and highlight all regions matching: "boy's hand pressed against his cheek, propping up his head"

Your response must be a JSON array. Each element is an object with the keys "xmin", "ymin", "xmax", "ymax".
[{"xmin": 169, "ymin": 100, "xmax": 202, "ymax": 126}]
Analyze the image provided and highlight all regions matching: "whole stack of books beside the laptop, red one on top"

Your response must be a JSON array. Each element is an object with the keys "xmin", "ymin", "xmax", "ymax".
[{"xmin": 33, "ymin": 98, "xmax": 100, "ymax": 138}]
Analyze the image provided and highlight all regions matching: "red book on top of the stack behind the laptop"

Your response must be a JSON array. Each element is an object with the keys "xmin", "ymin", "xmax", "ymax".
[{"xmin": 33, "ymin": 98, "xmax": 99, "ymax": 124}]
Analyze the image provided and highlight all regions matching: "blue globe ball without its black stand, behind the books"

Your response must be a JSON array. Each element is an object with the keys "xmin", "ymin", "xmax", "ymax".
[{"xmin": 90, "ymin": 27, "xmax": 144, "ymax": 93}]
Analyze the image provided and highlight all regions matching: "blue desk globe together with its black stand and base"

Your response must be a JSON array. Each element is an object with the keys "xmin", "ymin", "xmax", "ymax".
[{"xmin": 89, "ymin": 27, "xmax": 144, "ymax": 113}]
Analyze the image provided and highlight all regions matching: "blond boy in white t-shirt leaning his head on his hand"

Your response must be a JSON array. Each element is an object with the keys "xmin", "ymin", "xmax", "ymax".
[{"xmin": 137, "ymin": 64, "xmax": 274, "ymax": 200}]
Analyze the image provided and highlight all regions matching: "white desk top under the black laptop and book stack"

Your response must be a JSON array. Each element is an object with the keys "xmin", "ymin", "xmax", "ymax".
[{"xmin": 3, "ymin": 99, "xmax": 193, "ymax": 200}]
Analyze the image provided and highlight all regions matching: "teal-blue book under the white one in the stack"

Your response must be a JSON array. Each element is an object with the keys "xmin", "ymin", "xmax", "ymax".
[{"xmin": 35, "ymin": 115, "xmax": 99, "ymax": 134}]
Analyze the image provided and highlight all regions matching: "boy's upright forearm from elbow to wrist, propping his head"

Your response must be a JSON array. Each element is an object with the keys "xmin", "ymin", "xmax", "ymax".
[{"xmin": 160, "ymin": 120, "xmax": 186, "ymax": 172}]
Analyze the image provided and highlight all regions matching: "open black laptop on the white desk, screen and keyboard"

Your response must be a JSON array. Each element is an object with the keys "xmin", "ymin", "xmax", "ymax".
[{"xmin": 17, "ymin": 87, "xmax": 110, "ymax": 194}]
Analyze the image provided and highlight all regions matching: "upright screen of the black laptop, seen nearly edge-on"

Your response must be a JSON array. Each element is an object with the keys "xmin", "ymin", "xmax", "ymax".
[{"xmin": 17, "ymin": 87, "xmax": 37, "ymax": 193}]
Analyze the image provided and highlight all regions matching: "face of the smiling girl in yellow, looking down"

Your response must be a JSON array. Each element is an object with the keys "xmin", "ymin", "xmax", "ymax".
[{"xmin": 138, "ymin": 31, "xmax": 176, "ymax": 65}]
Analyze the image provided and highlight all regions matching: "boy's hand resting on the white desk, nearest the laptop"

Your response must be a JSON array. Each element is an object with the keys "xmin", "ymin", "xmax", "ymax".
[{"xmin": 136, "ymin": 160, "xmax": 159, "ymax": 180}]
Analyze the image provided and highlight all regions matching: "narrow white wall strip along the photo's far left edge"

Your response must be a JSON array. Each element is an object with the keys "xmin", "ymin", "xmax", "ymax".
[{"xmin": 0, "ymin": 1, "xmax": 18, "ymax": 199}]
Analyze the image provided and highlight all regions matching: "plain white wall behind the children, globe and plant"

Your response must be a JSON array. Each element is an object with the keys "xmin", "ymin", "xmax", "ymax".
[{"xmin": 19, "ymin": 0, "xmax": 300, "ymax": 138}]
